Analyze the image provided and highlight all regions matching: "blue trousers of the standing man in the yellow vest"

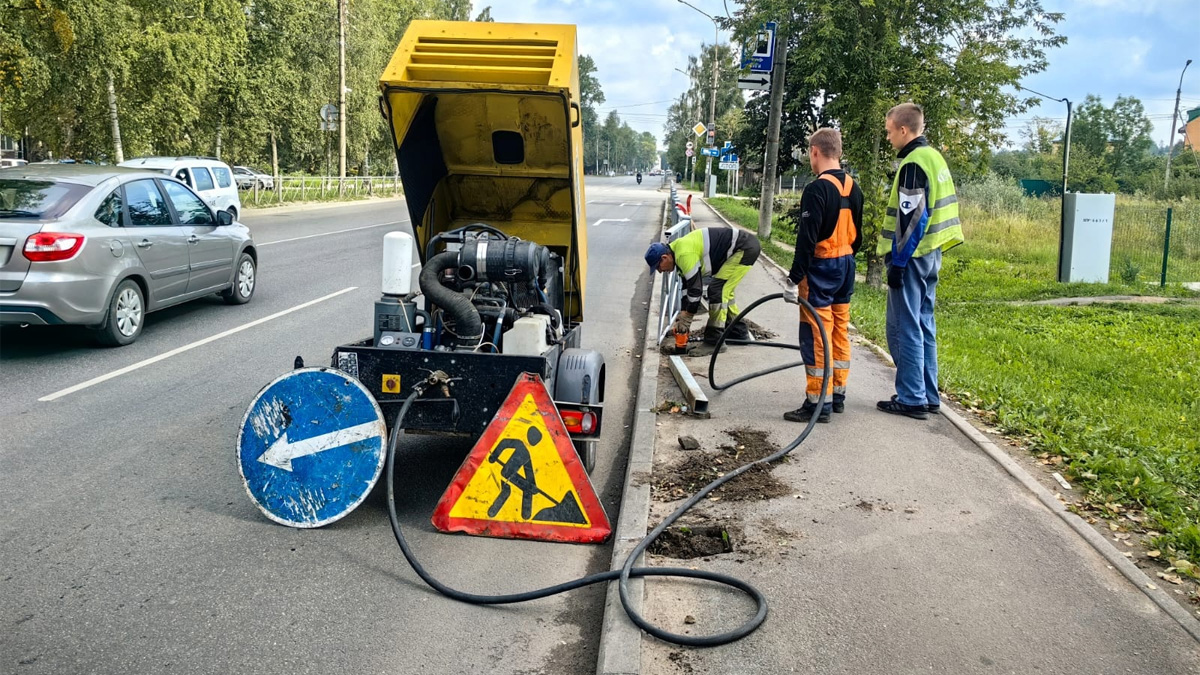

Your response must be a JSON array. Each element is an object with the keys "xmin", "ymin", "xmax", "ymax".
[{"xmin": 887, "ymin": 250, "xmax": 942, "ymax": 406}]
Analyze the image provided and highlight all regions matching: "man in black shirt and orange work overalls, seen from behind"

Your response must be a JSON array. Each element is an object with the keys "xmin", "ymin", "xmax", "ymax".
[{"xmin": 784, "ymin": 129, "xmax": 863, "ymax": 422}]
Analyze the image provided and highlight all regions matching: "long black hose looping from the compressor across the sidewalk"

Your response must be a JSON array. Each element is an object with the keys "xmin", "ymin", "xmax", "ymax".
[{"xmin": 384, "ymin": 293, "xmax": 832, "ymax": 647}]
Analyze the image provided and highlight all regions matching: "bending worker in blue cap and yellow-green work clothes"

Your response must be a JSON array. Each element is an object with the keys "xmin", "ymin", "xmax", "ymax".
[{"xmin": 646, "ymin": 227, "xmax": 762, "ymax": 357}]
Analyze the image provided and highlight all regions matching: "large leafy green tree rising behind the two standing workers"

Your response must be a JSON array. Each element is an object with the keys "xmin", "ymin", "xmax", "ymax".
[{"xmin": 730, "ymin": 0, "xmax": 1066, "ymax": 283}]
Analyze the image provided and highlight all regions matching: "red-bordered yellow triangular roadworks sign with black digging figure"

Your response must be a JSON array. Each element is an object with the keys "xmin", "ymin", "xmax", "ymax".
[{"xmin": 432, "ymin": 372, "xmax": 612, "ymax": 544}]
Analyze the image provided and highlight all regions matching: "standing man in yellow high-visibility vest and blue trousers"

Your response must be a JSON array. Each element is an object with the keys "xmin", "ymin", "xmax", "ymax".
[{"xmin": 877, "ymin": 103, "xmax": 962, "ymax": 419}]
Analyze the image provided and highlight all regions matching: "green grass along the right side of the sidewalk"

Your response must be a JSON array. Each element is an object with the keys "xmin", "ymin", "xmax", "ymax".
[{"xmin": 710, "ymin": 192, "xmax": 1200, "ymax": 562}]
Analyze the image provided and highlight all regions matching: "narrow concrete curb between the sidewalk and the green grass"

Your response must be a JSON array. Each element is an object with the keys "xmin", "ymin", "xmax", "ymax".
[{"xmin": 858, "ymin": 319, "xmax": 1200, "ymax": 643}]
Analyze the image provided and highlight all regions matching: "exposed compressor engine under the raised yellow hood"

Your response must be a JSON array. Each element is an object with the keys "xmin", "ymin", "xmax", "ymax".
[{"xmin": 374, "ymin": 223, "xmax": 564, "ymax": 356}]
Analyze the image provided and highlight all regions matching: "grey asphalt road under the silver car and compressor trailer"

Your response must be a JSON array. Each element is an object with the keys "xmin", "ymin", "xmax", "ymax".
[{"xmin": 0, "ymin": 178, "xmax": 662, "ymax": 675}]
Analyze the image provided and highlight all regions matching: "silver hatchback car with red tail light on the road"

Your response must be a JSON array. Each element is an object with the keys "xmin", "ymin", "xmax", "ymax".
[{"xmin": 0, "ymin": 165, "xmax": 258, "ymax": 346}]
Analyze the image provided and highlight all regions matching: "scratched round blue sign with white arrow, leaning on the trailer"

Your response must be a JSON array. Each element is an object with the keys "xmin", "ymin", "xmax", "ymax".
[{"xmin": 238, "ymin": 368, "xmax": 388, "ymax": 527}]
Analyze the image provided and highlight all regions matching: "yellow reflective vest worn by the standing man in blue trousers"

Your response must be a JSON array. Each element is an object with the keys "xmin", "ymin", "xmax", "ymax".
[{"xmin": 876, "ymin": 145, "xmax": 964, "ymax": 258}]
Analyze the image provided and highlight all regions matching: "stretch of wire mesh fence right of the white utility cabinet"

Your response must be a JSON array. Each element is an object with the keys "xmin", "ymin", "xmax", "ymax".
[{"xmin": 1109, "ymin": 202, "xmax": 1200, "ymax": 286}]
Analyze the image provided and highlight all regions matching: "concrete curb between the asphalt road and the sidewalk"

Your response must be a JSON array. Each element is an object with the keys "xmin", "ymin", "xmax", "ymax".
[{"xmin": 596, "ymin": 196, "xmax": 667, "ymax": 675}]
